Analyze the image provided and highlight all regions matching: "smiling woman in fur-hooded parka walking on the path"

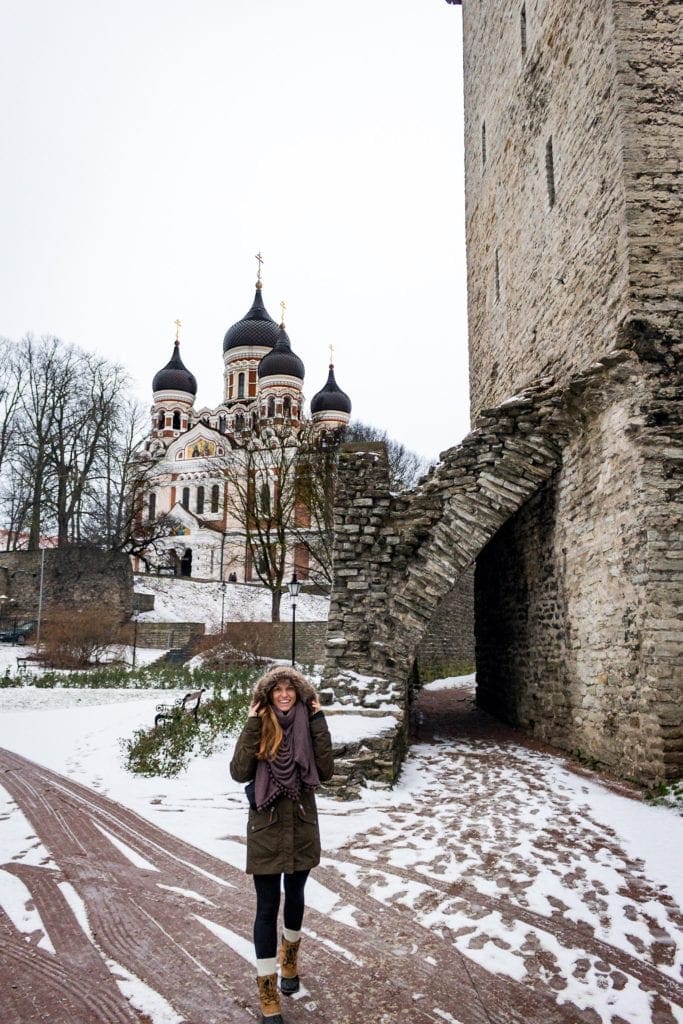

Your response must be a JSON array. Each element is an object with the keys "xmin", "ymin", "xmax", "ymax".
[{"xmin": 230, "ymin": 666, "xmax": 334, "ymax": 1024}]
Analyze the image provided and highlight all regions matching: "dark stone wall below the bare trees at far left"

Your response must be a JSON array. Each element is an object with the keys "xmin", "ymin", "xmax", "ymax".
[{"xmin": 0, "ymin": 547, "xmax": 133, "ymax": 623}]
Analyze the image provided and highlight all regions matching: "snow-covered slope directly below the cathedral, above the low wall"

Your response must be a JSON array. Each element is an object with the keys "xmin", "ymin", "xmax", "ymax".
[{"xmin": 135, "ymin": 575, "xmax": 330, "ymax": 630}]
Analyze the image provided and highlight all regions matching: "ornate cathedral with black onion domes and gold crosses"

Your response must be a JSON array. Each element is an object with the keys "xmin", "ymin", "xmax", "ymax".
[{"xmin": 133, "ymin": 264, "xmax": 351, "ymax": 583}]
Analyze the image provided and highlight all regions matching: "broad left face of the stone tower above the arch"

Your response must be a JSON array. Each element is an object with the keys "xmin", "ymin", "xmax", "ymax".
[{"xmin": 463, "ymin": 0, "xmax": 629, "ymax": 417}]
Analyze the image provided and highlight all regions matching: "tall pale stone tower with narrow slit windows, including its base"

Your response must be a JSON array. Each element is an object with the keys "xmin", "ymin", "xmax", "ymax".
[{"xmin": 456, "ymin": 0, "xmax": 683, "ymax": 778}]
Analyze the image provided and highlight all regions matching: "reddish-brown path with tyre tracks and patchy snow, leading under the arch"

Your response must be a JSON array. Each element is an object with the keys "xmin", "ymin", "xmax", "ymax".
[{"xmin": 0, "ymin": 693, "xmax": 683, "ymax": 1024}]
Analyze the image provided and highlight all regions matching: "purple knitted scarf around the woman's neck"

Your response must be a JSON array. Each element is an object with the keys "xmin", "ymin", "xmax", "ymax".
[{"xmin": 255, "ymin": 700, "xmax": 321, "ymax": 811}]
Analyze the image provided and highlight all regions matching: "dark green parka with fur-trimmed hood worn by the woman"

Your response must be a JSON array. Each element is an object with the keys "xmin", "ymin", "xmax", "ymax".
[{"xmin": 230, "ymin": 667, "xmax": 334, "ymax": 874}]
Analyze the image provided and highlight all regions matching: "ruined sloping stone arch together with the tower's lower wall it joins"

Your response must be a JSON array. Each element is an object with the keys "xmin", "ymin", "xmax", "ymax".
[{"xmin": 325, "ymin": 344, "xmax": 683, "ymax": 782}]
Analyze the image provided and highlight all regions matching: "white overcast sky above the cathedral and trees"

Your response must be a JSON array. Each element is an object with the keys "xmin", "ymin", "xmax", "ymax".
[{"xmin": 0, "ymin": 0, "xmax": 468, "ymax": 457}]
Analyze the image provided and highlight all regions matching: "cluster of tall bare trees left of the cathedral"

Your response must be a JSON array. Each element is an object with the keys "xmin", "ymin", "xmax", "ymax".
[{"xmin": 0, "ymin": 335, "xmax": 152, "ymax": 550}]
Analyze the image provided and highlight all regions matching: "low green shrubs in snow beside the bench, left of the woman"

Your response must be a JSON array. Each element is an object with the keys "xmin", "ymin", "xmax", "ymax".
[{"xmin": 123, "ymin": 668, "xmax": 263, "ymax": 778}]
